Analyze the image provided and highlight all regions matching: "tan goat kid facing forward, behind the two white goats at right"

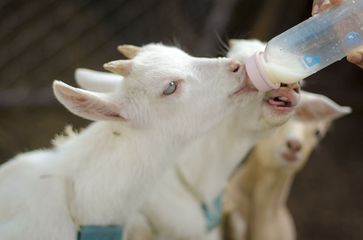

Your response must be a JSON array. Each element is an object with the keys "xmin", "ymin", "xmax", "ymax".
[{"xmin": 224, "ymin": 93, "xmax": 351, "ymax": 240}]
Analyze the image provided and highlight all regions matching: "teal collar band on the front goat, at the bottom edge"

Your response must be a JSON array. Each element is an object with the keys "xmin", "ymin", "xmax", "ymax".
[{"xmin": 77, "ymin": 225, "xmax": 123, "ymax": 240}]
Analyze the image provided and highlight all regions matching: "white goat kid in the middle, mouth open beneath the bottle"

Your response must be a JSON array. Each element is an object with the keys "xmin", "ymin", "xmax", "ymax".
[{"xmin": 76, "ymin": 41, "xmax": 299, "ymax": 240}]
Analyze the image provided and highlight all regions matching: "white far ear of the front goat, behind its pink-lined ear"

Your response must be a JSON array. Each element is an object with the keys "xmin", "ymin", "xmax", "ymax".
[{"xmin": 74, "ymin": 68, "xmax": 123, "ymax": 92}]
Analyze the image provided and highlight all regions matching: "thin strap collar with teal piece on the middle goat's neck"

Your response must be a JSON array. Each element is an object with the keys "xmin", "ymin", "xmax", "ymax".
[{"xmin": 175, "ymin": 166, "xmax": 223, "ymax": 232}]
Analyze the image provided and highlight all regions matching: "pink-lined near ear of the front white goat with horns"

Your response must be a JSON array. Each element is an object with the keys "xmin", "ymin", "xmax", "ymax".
[{"xmin": 53, "ymin": 81, "xmax": 126, "ymax": 121}]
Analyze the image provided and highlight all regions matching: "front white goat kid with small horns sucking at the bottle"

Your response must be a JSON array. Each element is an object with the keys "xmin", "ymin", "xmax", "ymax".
[{"xmin": 0, "ymin": 44, "xmax": 246, "ymax": 240}]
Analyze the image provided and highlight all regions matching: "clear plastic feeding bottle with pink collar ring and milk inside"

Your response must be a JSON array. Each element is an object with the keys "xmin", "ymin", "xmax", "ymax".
[{"xmin": 246, "ymin": 0, "xmax": 363, "ymax": 91}]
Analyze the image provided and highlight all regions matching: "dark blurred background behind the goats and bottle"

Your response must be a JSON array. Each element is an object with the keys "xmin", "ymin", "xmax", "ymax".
[{"xmin": 0, "ymin": 0, "xmax": 363, "ymax": 240}]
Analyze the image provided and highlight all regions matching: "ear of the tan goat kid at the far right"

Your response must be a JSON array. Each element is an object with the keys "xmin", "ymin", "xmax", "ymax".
[{"xmin": 295, "ymin": 91, "xmax": 352, "ymax": 121}]
